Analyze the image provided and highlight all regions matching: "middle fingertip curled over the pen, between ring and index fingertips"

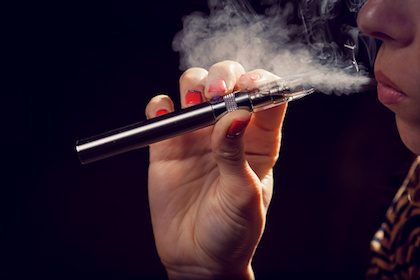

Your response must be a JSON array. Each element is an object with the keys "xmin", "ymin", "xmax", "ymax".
[{"xmin": 204, "ymin": 60, "xmax": 245, "ymax": 99}]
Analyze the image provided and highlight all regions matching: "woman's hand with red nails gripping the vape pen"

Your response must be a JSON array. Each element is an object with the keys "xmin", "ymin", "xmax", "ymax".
[{"xmin": 146, "ymin": 61, "xmax": 286, "ymax": 279}]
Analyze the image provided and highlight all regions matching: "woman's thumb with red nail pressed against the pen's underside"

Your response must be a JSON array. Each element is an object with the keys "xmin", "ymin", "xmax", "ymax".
[{"xmin": 211, "ymin": 110, "xmax": 259, "ymax": 193}]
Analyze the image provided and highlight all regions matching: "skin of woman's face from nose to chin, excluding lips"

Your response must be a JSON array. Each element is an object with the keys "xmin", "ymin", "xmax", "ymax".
[{"xmin": 358, "ymin": 0, "xmax": 420, "ymax": 155}]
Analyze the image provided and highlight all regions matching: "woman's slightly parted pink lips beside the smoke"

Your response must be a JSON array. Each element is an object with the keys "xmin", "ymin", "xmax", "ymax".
[{"xmin": 375, "ymin": 71, "xmax": 407, "ymax": 105}]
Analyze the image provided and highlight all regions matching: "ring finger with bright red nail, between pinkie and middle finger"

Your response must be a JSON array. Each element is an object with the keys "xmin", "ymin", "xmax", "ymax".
[{"xmin": 179, "ymin": 67, "xmax": 208, "ymax": 108}]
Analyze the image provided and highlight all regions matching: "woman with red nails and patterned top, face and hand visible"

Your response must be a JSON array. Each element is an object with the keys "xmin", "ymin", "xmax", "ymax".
[{"xmin": 146, "ymin": 0, "xmax": 420, "ymax": 279}]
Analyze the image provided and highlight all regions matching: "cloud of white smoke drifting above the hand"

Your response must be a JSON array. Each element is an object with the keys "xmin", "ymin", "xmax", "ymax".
[{"xmin": 173, "ymin": 0, "xmax": 370, "ymax": 94}]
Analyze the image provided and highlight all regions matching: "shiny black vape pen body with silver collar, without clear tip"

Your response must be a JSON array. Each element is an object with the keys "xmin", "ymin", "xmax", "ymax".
[{"xmin": 76, "ymin": 92, "xmax": 252, "ymax": 164}]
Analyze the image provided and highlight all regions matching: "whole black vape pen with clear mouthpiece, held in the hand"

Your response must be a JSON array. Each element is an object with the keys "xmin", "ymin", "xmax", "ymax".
[{"xmin": 76, "ymin": 78, "xmax": 314, "ymax": 164}]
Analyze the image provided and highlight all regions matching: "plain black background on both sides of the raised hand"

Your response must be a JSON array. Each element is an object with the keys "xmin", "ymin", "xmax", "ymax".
[{"xmin": 0, "ymin": 0, "xmax": 412, "ymax": 279}]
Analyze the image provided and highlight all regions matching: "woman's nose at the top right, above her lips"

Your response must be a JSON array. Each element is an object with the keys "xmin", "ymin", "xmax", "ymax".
[{"xmin": 357, "ymin": 0, "xmax": 418, "ymax": 46}]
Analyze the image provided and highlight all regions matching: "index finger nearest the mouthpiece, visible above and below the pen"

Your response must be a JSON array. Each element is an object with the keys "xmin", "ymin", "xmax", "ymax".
[{"xmin": 238, "ymin": 69, "xmax": 287, "ymax": 131}]
